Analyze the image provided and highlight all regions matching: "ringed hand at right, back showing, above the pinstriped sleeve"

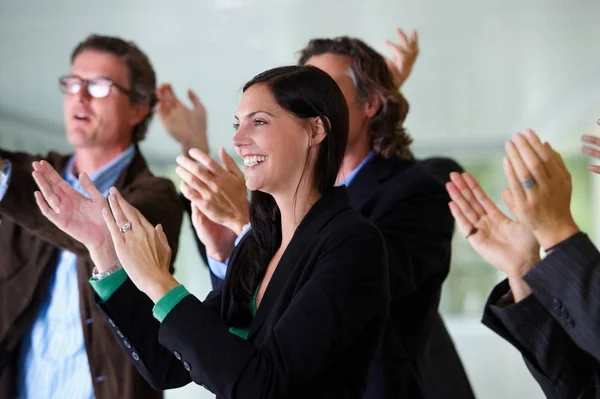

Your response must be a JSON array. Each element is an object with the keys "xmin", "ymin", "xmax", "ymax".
[{"xmin": 504, "ymin": 130, "xmax": 579, "ymax": 249}]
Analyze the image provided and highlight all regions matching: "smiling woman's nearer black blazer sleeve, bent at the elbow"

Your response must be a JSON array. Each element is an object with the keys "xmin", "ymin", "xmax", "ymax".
[{"xmin": 152, "ymin": 223, "xmax": 389, "ymax": 398}]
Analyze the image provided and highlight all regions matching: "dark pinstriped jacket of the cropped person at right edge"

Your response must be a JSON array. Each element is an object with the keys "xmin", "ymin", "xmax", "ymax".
[{"xmin": 482, "ymin": 233, "xmax": 600, "ymax": 398}]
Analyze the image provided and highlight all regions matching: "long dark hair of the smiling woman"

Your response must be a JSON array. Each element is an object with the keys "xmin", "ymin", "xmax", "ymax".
[{"xmin": 229, "ymin": 66, "xmax": 349, "ymax": 325}]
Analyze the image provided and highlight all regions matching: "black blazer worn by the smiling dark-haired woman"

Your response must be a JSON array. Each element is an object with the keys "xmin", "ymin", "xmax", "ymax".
[{"xmin": 100, "ymin": 188, "xmax": 389, "ymax": 398}]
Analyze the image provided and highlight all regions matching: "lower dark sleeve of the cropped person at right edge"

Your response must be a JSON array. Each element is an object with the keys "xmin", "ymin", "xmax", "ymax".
[{"xmin": 483, "ymin": 281, "xmax": 600, "ymax": 398}]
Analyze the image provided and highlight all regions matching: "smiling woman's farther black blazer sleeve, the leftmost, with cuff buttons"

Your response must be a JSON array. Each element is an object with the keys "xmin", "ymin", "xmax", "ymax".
[{"xmin": 96, "ymin": 279, "xmax": 221, "ymax": 390}]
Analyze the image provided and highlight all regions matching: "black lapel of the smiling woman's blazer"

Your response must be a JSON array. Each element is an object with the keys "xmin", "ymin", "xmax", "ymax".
[{"xmin": 248, "ymin": 187, "xmax": 350, "ymax": 339}]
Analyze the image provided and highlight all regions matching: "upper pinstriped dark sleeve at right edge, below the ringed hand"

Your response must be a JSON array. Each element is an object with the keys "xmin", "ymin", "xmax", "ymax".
[{"xmin": 524, "ymin": 233, "xmax": 600, "ymax": 361}]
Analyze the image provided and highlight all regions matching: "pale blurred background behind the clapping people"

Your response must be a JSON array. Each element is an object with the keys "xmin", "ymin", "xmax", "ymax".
[{"xmin": 0, "ymin": 0, "xmax": 600, "ymax": 399}]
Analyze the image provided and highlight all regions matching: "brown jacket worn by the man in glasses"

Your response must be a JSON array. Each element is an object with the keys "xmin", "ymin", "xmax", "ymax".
[{"xmin": 0, "ymin": 150, "xmax": 183, "ymax": 399}]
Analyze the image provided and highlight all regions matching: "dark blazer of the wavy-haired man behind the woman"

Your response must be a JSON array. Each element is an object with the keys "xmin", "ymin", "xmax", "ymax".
[{"xmin": 349, "ymin": 156, "xmax": 472, "ymax": 399}]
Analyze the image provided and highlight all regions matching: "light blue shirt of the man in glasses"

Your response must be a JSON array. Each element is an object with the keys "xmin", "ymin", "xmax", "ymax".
[{"xmin": 8, "ymin": 145, "xmax": 135, "ymax": 399}]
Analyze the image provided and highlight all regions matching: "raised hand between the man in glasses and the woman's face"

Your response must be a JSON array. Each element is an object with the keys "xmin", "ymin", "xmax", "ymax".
[{"xmin": 156, "ymin": 83, "xmax": 208, "ymax": 154}]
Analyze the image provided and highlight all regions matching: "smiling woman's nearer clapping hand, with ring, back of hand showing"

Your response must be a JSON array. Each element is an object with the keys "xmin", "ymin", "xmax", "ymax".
[{"xmin": 102, "ymin": 187, "xmax": 179, "ymax": 303}]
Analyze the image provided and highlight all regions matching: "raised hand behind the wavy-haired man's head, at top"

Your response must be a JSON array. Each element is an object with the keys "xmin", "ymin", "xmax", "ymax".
[{"xmin": 385, "ymin": 28, "xmax": 419, "ymax": 89}]
